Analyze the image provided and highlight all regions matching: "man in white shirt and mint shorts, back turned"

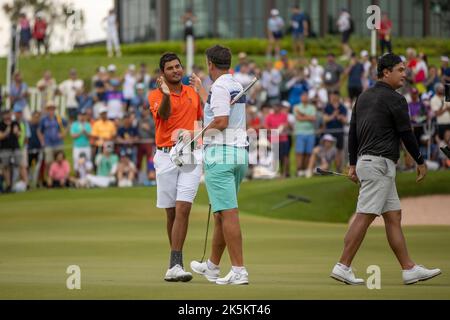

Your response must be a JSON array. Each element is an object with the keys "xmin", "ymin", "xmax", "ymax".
[{"xmin": 191, "ymin": 45, "xmax": 248, "ymax": 284}]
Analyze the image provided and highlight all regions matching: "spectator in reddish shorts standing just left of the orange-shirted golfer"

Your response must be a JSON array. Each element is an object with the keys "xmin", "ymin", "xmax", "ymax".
[{"xmin": 137, "ymin": 107, "xmax": 155, "ymax": 170}]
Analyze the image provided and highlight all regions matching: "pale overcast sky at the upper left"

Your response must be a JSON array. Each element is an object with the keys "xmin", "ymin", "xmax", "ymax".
[{"xmin": 0, "ymin": 0, "xmax": 114, "ymax": 56}]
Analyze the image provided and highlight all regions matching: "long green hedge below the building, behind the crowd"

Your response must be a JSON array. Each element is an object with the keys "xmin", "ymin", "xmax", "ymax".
[{"xmin": 68, "ymin": 36, "xmax": 450, "ymax": 56}]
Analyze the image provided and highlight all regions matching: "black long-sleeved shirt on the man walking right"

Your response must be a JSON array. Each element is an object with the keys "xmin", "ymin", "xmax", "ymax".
[{"xmin": 349, "ymin": 81, "xmax": 411, "ymax": 165}]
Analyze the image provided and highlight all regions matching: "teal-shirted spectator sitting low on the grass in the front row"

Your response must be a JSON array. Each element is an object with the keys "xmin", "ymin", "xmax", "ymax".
[{"xmin": 86, "ymin": 142, "xmax": 119, "ymax": 188}]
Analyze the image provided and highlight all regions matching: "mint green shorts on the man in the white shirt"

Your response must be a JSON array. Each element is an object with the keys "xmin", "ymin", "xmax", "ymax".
[{"xmin": 203, "ymin": 145, "xmax": 248, "ymax": 212}]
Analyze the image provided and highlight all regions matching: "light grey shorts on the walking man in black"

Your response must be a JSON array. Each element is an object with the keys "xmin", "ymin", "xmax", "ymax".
[{"xmin": 356, "ymin": 155, "xmax": 401, "ymax": 216}]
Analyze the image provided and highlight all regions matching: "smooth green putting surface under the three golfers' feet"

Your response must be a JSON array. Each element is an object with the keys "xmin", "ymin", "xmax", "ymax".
[{"xmin": 0, "ymin": 179, "xmax": 450, "ymax": 299}]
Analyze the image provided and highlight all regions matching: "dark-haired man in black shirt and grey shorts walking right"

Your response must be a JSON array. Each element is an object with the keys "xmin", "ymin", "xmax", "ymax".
[{"xmin": 331, "ymin": 53, "xmax": 441, "ymax": 285}]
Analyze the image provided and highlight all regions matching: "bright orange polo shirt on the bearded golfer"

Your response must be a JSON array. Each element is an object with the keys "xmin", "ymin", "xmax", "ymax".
[{"xmin": 148, "ymin": 85, "xmax": 203, "ymax": 147}]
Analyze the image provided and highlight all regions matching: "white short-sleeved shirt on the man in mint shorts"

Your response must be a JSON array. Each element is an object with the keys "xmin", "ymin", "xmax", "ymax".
[{"xmin": 203, "ymin": 74, "xmax": 248, "ymax": 147}]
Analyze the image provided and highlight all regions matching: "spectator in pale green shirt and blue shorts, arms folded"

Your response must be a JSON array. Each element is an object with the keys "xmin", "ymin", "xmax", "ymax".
[{"xmin": 294, "ymin": 92, "xmax": 317, "ymax": 177}]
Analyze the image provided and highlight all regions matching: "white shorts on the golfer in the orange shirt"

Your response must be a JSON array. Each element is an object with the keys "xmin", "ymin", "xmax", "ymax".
[{"xmin": 153, "ymin": 150, "xmax": 202, "ymax": 209}]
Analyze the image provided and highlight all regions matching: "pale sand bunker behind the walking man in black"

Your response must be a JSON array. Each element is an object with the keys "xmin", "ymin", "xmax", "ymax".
[{"xmin": 349, "ymin": 195, "xmax": 450, "ymax": 226}]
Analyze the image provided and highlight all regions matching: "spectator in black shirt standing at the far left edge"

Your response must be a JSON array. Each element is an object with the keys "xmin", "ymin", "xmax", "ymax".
[{"xmin": 0, "ymin": 110, "xmax": 22, "ymax": 192}]
